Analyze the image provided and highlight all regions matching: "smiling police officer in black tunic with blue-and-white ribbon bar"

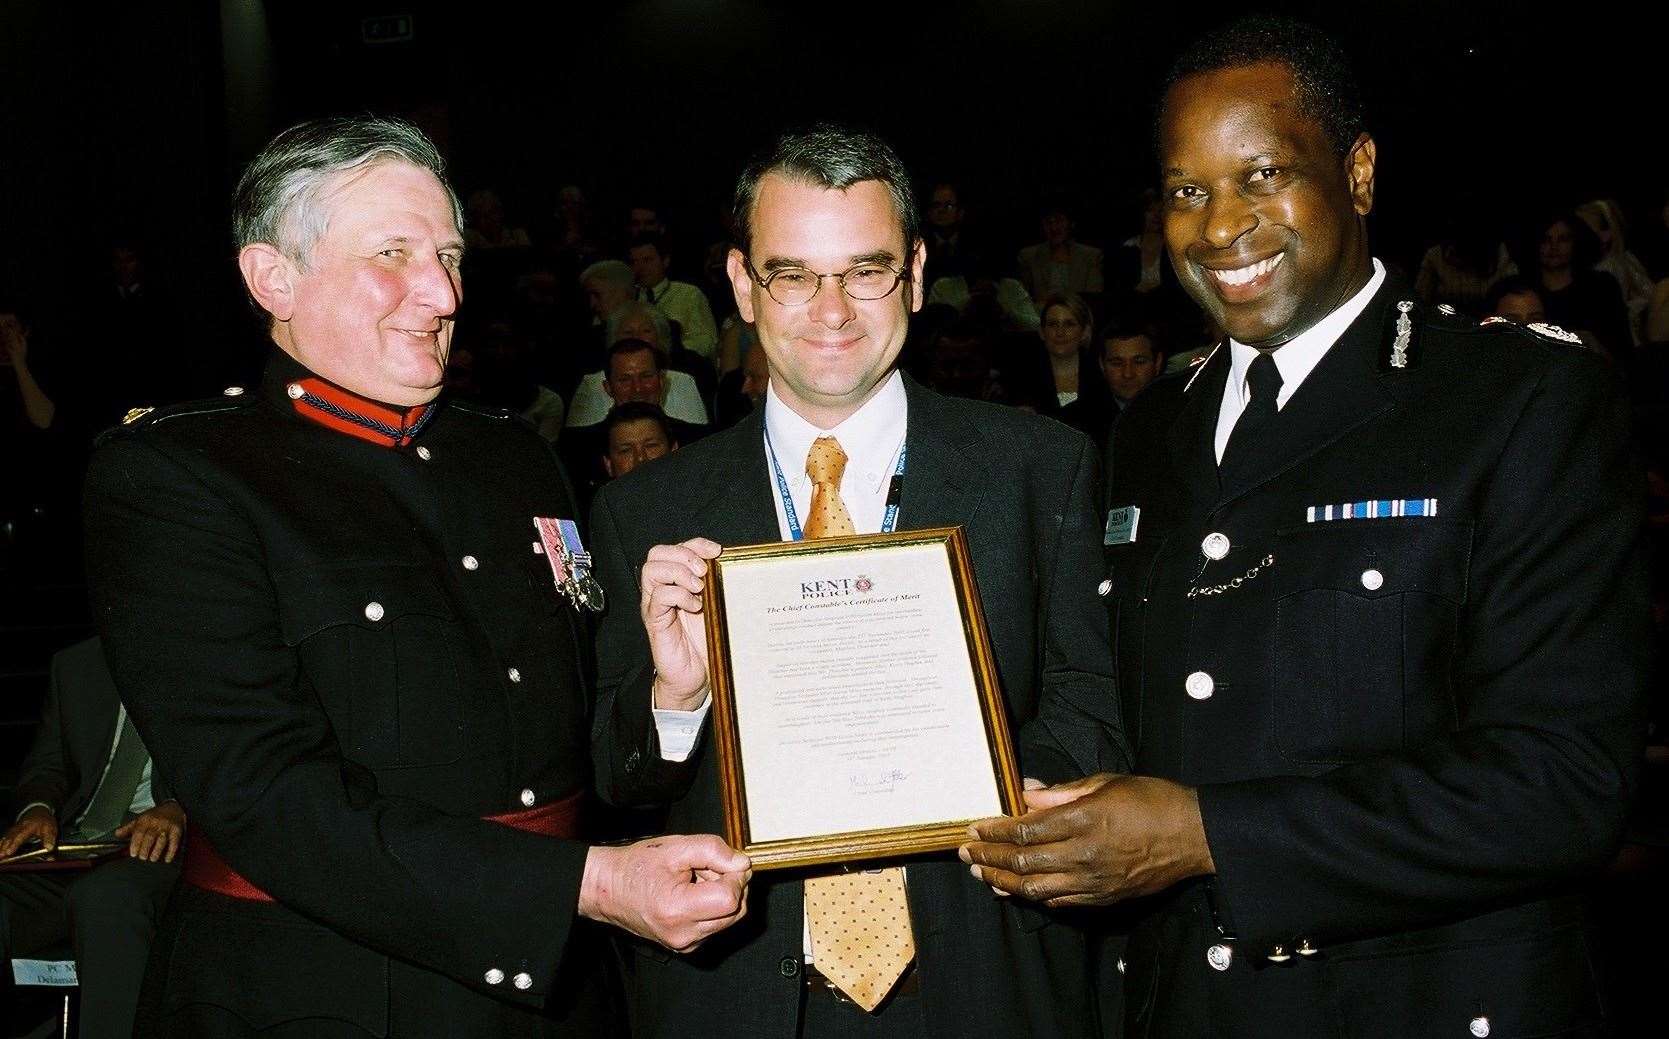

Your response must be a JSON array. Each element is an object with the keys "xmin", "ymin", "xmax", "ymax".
[{"xmin": 965, "ymin": 20, "xmax": 1646, "ymax": 1039}]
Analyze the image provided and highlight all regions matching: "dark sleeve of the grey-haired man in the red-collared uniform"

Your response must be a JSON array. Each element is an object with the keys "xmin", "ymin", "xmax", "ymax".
[{"xmin": 87, "ymin": 430, "xmax": 587, "ymax": 1006}]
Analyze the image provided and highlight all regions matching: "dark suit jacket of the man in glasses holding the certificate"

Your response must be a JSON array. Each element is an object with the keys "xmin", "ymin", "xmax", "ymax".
[{"xmin": 592, "ymin": 382, "xmax": 1125, "ymax": 1039}]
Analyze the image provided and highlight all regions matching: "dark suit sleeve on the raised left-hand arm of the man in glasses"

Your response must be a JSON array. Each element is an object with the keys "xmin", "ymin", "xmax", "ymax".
[{"xmin": 591, "ymin": 485, "xmax": 703, "ymax": 807}]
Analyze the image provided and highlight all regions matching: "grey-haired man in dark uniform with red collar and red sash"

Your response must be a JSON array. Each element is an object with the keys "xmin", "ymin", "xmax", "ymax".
[{"xmin": 87, "ymin": 117, "xmax": 748, "ymax": 1037}]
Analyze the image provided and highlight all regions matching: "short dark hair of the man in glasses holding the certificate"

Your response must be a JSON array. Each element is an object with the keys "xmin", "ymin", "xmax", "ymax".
[{"xmin": 731, "ymin": 123, "xmax": 921, "ymax": 260}]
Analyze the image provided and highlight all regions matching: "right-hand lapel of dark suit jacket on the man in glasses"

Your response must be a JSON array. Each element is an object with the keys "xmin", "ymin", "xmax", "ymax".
[{"xmin": 898, "ymin": 375, "xmax": 991, "ymax": 530}]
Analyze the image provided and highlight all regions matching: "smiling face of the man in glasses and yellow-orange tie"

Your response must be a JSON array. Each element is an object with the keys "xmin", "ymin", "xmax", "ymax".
[{"xmin": 726, "ymin": 173, "xmax": 926, "ymax": 429}]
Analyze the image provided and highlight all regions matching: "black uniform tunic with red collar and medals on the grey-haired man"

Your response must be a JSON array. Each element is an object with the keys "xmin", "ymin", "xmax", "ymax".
[{"xmin": 87, "ymin": 354, "xmax": 607, "ymax": 1036}]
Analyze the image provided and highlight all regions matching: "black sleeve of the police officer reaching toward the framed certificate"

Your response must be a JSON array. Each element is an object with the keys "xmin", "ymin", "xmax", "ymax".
[{"xmin": 1200, "ymin": 347, "xmax": 1647, "ymax": 947}]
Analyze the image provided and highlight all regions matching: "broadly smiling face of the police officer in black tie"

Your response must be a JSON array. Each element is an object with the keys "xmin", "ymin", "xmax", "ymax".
[{"xmin": 1160, "ymin": 63, "xmax": 1375, "ymax": 349}]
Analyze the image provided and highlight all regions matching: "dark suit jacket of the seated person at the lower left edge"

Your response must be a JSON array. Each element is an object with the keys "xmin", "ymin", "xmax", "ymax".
[{"xmin": 17, "ymin": 639, "xmax": 169, "ymax": 826}]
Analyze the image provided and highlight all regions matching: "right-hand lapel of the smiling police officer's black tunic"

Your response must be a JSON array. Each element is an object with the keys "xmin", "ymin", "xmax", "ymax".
[{"xmin": 1220, "ymin": 279, "xmax": 1399, "ymax": 502}]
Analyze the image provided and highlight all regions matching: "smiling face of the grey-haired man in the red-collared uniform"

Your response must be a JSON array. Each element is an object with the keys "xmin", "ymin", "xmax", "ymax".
[{"xmin": 272, "ymin": 162, "xmax": 464, "ymax": 407}]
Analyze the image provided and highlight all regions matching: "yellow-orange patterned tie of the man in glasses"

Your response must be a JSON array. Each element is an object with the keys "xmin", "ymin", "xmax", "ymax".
[{"xmin": 806, "ymin": 437, "xmax": 916, "ymax": 1011}]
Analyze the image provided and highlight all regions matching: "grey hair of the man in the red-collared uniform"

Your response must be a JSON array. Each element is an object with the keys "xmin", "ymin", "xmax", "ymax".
[{"xmin": 232, "ymin": 115, "xmax": 464, "ymax": 267}]
